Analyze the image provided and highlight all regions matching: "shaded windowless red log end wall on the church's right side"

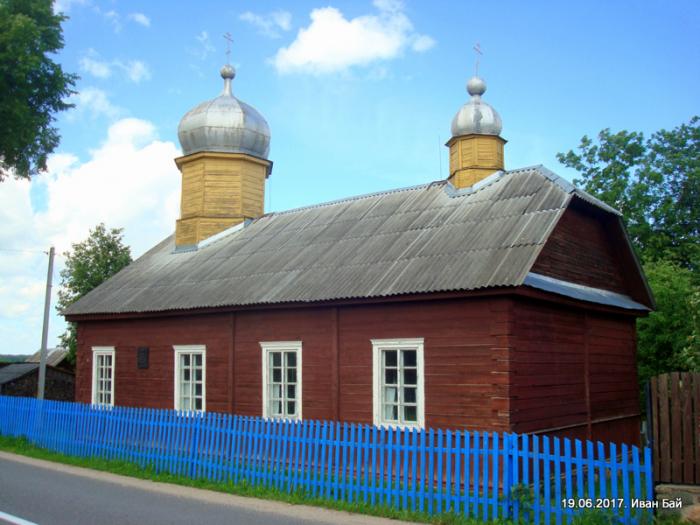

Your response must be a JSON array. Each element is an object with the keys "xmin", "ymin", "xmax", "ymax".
[{"xmin": 511, "ymin": 299, "xmax": 639, "ymax": 443}]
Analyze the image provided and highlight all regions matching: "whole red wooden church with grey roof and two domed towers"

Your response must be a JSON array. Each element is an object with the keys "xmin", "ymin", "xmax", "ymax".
[{"xmin": 65, "ymin": 66, "xmax": 653, "ymax": 442}]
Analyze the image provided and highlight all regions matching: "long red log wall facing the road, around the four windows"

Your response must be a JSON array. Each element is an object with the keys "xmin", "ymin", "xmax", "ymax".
[{"xmin": 76, "ymin": 298, "xmax": 511, "ymax": 430}]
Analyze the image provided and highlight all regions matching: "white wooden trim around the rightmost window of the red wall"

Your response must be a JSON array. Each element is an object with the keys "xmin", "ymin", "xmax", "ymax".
[{"xmin": 370, "ymin": 337, "xmax": 425, "ymax": 428}]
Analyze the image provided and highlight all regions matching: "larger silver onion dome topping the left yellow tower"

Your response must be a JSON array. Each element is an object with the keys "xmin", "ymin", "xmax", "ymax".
[{"xmin": 177, "ymin": 64, "xmax": 270, "ymax": 159}]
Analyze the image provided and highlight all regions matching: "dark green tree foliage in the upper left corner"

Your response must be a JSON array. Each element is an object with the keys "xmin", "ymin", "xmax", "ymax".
[{"xmin": 0, "ymin": 0, "xmax": 78, "ymax": 181}]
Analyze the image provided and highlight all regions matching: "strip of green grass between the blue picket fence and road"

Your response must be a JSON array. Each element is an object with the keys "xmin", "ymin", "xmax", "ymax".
[{"xmin": 0, "ymin": 435, "xmax": 684, "ymax": 525}]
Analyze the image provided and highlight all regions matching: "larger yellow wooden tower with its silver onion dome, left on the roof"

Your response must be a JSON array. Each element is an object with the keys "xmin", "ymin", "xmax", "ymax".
[{"xmin": 175, "ymin": 65, "xmax": 272, "ymax": 247}]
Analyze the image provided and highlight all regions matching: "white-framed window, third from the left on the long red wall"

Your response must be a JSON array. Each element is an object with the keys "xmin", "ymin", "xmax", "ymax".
[{"xmin": 260, "ymin": 341, "xmax": 302, "ymax": 419}]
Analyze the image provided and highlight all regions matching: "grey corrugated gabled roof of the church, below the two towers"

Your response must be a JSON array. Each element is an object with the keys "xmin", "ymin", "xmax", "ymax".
[{"xmin": 64, "ymin": 166, "xmax": 644, "ymax": 315}]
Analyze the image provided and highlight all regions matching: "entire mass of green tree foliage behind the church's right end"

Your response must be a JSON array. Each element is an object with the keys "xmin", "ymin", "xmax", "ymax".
[{"xmin": 557, "ymin": 117, "xmax": 700, "ymax": 382}]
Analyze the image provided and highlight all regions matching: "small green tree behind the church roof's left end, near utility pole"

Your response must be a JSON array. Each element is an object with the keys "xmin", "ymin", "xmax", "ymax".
[{"xmin": 56, "ymin": 223, "xmax": 131, "ymax": 362}]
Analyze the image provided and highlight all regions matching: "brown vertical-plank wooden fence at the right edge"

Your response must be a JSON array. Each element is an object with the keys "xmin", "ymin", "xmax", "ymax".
[{"xmin": 650, "ymin": 372, "xmax": 700, "ymax": 484}]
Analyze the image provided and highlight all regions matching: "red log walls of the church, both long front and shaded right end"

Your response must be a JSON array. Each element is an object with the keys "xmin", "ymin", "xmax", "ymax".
[{"xmin": 76, "ymin": 296, "xmax": 638, "ymax": 442}]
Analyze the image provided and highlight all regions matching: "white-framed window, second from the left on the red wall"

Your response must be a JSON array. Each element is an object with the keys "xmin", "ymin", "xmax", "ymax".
[{"xmin": 173, "ymin": 345, "xmax": 207, "ymax": 412}]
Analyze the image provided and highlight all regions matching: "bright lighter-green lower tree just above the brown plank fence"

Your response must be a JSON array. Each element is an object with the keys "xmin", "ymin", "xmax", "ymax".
[{"xmin": 637, "ymin": 260, "xmax": 700, "ymax": 384}]
